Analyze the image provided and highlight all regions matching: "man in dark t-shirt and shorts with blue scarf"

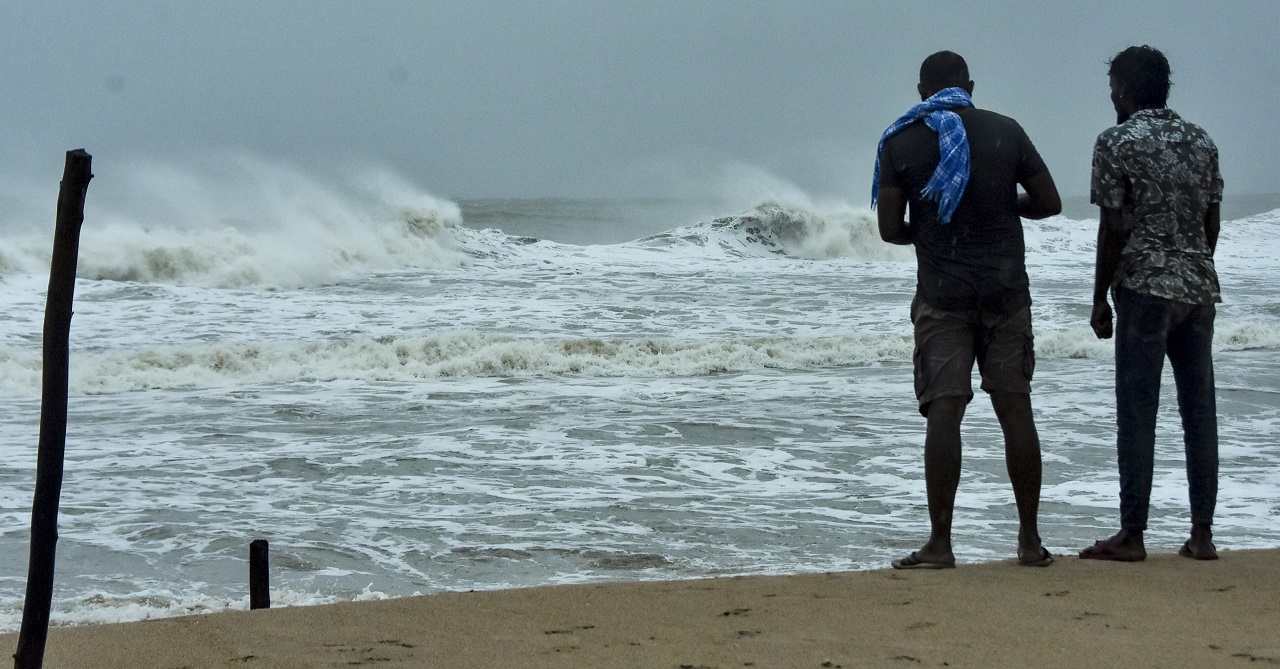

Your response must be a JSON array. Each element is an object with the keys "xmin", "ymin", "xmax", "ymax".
[{"xmin": 873, "ymin": 51, "xmax": 1062, "ymax": 569}]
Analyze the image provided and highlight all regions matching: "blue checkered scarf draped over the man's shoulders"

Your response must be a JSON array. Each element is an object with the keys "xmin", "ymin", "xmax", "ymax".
[{"xmin": 872, "ymin": 88, "xmax": 973, "ymax": 223}]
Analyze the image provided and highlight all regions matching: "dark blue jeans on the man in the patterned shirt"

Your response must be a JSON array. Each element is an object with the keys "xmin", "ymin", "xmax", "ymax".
[{"xmin": 1115, "ymin": 288, "xmax": 1217, "ymax": 530}]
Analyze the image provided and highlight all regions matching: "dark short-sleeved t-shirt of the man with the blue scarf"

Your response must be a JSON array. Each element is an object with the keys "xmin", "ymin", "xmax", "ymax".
[{"xmin": 879, "ymin": 109, "xmax": 1046, "ymax": 313}]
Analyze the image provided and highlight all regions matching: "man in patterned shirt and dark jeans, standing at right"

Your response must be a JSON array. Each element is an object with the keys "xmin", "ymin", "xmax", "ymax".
[{"xmin": 1080, "ymin": 46, "xmax": 1222, "ymax": 562}]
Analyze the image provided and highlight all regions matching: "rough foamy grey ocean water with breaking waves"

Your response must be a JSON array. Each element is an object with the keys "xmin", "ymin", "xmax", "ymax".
[{"xmin": 0, "ymin": 164, "xmax": 1280, "ymax": 631}]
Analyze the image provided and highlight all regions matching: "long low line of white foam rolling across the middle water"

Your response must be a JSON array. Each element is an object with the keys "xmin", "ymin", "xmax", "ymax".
[{"xmin": 0, "ymin": 321, "xmax": 1280, "ymax": 397}]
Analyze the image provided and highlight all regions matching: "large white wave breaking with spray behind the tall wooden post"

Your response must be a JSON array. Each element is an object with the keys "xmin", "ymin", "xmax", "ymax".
[{"xmin": 0, "ymin": 156, "xmax": 466, "ymax": 288}]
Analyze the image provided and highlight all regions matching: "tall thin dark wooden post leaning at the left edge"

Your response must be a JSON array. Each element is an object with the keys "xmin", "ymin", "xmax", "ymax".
[{"xmin": 13, "ymin": 148, "xmax": 93, "ymax": 669}]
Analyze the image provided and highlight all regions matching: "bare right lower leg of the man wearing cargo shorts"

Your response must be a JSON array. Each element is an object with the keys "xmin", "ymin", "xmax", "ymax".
[{"xmin": 991, "ymin": 391, "xmax": 1044, "ymax": 563}]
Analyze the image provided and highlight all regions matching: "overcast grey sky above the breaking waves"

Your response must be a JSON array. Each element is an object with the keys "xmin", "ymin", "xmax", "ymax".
[{"xmin": 0, "ymin": 0, "xmax": 1280, "ymax": 205}]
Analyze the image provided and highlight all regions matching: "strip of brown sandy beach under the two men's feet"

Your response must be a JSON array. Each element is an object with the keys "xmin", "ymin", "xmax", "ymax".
[{"xmin": 0, "ymin": 550, "xmax": 1280, "ymax": 669}]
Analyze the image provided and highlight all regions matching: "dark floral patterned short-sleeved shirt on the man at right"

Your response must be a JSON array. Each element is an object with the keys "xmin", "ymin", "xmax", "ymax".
[{"xmin": 1089, "ymin": 109, "xmax": 1222, "ymax": 304}]
